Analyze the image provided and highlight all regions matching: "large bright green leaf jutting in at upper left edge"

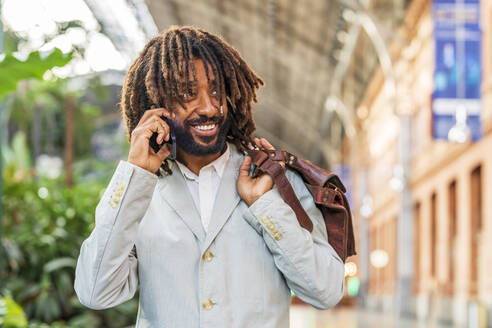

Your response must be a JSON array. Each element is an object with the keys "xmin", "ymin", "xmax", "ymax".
[{"xmin": 0, "ymin": 48, "xmax": 72, "ymax": 100}]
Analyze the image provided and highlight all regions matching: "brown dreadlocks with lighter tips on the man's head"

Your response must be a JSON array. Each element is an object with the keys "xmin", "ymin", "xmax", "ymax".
[{"xmin": 121, "ymin": 26, "xmax": 264, "ymax": 175}]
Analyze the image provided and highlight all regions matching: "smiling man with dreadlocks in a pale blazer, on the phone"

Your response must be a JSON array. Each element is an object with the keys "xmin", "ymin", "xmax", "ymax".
[{"xmin": 75, "ymin": 26, "xmax": 344, "ymax": 328}]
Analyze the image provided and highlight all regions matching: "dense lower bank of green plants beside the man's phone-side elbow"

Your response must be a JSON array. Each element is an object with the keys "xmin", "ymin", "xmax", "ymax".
[{"xmin": 0, "ymin": 132, "xmax": 138, "ymax": 327}]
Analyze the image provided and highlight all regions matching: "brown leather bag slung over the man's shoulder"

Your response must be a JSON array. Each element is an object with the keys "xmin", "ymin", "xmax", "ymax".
[{"xmin": 249, "ymin": 149, "xmax": 356, "ymax": 262}]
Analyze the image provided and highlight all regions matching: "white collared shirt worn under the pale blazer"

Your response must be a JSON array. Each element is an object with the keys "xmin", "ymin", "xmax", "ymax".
[{"xmin": 176, "ymin": 144, "xmax": 231, "ymax": 231}]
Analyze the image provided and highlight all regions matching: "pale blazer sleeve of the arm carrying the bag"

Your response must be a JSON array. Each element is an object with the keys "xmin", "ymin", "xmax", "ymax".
[{"xmin": 243, "ymin": 170, "xmax": 345, "ymax": 309}]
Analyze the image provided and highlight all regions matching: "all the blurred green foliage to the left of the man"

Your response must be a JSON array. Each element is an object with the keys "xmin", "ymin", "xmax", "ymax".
[{"xmin": 0, "ymin": 16, "xmax": 138, "ymax": 328}]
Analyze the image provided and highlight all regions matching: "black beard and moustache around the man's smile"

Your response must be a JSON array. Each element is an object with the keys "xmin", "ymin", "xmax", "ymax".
[{"xmin": 169, "ymin": 115, "xmax": 231, "ymax": 156}]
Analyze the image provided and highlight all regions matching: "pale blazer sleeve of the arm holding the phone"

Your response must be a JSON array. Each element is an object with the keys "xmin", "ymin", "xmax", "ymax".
[{"xmin": 74, "ymin": 161, "xmax": 158, "ymax": 310}]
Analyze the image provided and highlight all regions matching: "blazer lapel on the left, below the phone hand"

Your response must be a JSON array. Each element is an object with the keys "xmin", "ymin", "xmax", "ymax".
[{"xmin": 159, "ymin": 161, "xmax": 205, "ymax": 243}]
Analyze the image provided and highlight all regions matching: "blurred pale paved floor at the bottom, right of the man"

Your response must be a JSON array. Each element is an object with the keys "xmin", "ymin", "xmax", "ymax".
[{"xmin": 290, "ymin": 305, "xmax": 452, "ymax": 328}]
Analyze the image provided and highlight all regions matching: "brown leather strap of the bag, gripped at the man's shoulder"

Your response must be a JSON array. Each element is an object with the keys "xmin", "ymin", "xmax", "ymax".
[{"xmin": 249, "ymin": 150, "xmax": 313, "ymax": 232}]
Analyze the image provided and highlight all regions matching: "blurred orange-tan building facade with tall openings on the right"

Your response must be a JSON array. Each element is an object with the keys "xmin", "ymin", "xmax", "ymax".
[{"xmin": 350, "ymin": 0, "xmax": 492, "ymax": 327}]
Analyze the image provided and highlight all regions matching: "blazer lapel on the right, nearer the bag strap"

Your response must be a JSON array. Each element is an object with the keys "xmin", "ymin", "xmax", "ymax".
[{"xmin": 202, "ymin": 149, "xmax": 243, "ymax": 253}]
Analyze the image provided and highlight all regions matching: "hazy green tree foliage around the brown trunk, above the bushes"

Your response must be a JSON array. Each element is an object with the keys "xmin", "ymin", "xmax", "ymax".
[{"xmin": 5, "ymin": 77, "xmax": 108, "ymax": 158}]
